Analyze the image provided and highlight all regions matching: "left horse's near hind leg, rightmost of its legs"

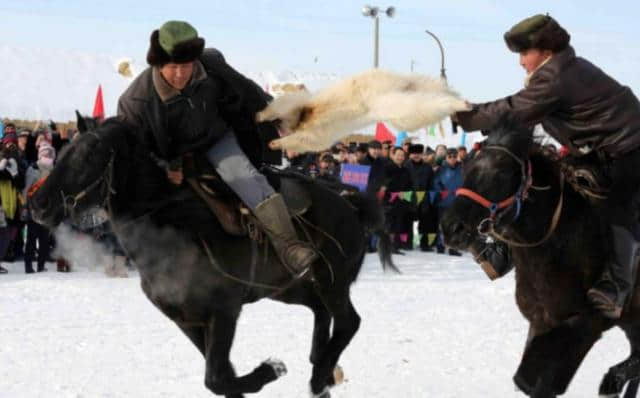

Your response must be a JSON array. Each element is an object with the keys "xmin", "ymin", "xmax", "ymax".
[{"xmin": 310, "ymin": 287, "xmax": 360, "ymax": 398}]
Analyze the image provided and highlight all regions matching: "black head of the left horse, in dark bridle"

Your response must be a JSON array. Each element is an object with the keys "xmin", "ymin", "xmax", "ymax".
[{"xmin": 29, "ymin": 119, "xmax": 127, "ymax": 227}]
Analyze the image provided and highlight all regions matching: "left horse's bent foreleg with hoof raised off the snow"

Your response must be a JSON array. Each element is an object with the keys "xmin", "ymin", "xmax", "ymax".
[{"xmin": 204, "ymin": 313, "xmax": 286, "ymax": 398}]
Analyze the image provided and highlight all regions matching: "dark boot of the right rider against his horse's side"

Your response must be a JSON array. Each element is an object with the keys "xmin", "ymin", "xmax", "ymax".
[{"xmin": 587, "ymin": 225, "xmax": 640, "ymax": 319}]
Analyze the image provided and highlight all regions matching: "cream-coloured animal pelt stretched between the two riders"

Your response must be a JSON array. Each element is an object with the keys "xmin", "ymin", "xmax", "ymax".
[{"xmin": 256, "ymin": 69, "xmax": 469, "ymax": 152}]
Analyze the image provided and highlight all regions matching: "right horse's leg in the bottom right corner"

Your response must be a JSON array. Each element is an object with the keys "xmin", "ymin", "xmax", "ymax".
[{"xmin": 599, "ymin": 330, "xmax": 640, "ymax": 398}]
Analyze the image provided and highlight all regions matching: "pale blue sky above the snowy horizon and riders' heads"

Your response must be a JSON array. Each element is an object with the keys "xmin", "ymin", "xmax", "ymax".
[{"xmin": 0, "ymin": 0, "xmax": 640, "ymax": 101}]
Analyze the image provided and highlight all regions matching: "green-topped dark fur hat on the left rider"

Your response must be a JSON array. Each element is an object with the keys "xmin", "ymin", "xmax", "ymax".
[{"xmin": 147, "ymin": 21, "xmax": 204, "ymax": 66}]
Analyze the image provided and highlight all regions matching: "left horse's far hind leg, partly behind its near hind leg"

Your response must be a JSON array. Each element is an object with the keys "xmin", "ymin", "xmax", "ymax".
[{"xmin": 274, "ymin": 281, "xmax": 331, "ymax": 365}]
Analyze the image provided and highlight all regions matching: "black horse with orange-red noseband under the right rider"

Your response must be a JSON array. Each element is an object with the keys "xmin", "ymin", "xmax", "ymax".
[{"xmin": 441, "ymin": 125, "xmax": 640, "ymax": 397}]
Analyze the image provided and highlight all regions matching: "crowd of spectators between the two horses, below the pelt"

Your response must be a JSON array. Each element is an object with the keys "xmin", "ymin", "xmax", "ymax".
[{"xmin": 286, "ymin": 140, "xmax": 467, "ymax": 256}]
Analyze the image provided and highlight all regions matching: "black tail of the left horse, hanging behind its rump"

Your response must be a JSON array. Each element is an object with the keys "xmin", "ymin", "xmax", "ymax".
[{"xmin": 345, "ymin": 193, "xmax": 401, "ymax": 273}]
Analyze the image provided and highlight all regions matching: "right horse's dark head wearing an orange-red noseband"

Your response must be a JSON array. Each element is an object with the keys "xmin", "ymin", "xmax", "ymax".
[{"xmin": 441, "ymin": 122, "xmax": 533, "ymax": 255}]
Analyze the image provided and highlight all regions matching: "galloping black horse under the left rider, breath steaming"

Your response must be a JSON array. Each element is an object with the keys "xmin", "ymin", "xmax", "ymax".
[{"xmin": 31, "ymin": 119, "xmax": 392, "ymax": 398}]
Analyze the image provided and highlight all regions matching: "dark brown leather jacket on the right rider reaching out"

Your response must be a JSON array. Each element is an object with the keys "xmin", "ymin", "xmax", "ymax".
[{"xmin": 456, "ymin": 46, "xmax": 640, "ymax": 158}]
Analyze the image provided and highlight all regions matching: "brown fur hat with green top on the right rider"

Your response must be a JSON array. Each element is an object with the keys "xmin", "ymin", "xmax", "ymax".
[{"xmin": 504, "ymin": 14, "xmax": 571, "ymax": 53}]
